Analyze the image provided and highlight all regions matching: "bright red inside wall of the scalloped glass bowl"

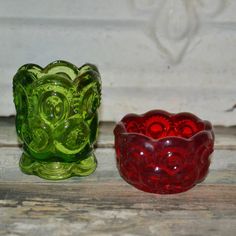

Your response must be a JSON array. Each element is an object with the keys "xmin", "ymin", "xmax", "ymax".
[{"xmin": 122, "ymin": 112, "xmax": 205, "ymax": 139}]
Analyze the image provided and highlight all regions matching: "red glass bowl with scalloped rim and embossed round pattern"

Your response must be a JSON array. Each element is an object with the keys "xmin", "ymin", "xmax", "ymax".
[{"xmin": 114, "ymin": 110, "xmax": 214, "ymax": 194}]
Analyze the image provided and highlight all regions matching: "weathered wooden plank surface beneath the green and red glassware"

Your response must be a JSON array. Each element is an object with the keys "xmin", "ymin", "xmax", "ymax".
[{"xmin": 0, "ymin": 117, "xmax": 236, "ymax": 236}]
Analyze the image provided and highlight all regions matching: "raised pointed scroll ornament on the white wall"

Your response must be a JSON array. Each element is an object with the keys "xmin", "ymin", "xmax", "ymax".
[{"xmin": 132, "ymin": 0, "xmax": 226, "ymax": 64}]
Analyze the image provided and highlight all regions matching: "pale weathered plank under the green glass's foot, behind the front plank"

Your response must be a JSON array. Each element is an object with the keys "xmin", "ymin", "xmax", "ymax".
[{"xmin": 0, "ymin": 147, "xmax": 236, "ymax": 184}]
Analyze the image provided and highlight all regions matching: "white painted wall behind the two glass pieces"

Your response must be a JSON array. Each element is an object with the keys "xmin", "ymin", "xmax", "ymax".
[{"xmin": 0, "ymin": 0, "xmax": 236, "ymax": 125}]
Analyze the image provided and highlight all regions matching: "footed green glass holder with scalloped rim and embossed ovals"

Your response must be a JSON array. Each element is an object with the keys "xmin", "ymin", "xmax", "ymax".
[{"xmin": 13, "ymin": 61, "xmax": 101, "ymax": 180}]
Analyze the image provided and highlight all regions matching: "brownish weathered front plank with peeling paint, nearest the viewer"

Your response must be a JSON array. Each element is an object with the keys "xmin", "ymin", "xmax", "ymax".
[{"xmin": 0, "ymin": 181, "xmax": 236, "ymax": 236}]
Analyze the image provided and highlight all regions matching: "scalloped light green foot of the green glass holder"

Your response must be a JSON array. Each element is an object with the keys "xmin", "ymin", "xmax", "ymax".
[{"xmin": 19, "ymin": 153, "xmax": 97, "ymax": 180}]
